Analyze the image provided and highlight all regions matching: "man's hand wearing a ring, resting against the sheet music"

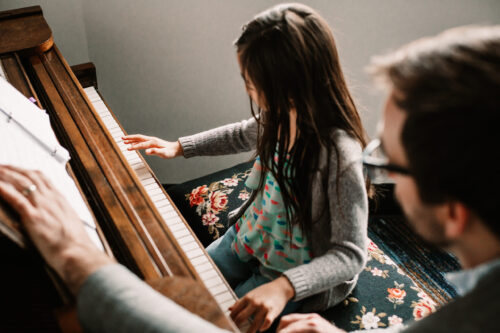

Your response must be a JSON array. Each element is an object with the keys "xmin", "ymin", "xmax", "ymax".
[{"xmin": 0, "ymin": 166, "xmax": 113, "ymax": 294}]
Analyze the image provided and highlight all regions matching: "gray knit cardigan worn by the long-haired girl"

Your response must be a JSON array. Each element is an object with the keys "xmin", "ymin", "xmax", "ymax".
[{"xmin": 179, "ymin": 118, "xmax": 368, "ymax": 311}]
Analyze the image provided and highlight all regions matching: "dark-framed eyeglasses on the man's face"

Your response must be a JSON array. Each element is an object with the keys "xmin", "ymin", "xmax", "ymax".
[{"xmin": 362, "ymin": 139, "xmax": 410, "ymax": 182}]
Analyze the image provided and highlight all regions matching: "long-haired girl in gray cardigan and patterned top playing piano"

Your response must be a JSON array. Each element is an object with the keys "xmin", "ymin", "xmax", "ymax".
[{"xmin": 123, "ymin": 4, "xmax": 367, "ymax": 331}]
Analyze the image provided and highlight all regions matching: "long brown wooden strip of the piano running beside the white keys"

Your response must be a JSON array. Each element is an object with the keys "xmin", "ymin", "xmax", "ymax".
[{"xmin": 41, "ymin": 47, "xmax": 209, "ymax": 278}]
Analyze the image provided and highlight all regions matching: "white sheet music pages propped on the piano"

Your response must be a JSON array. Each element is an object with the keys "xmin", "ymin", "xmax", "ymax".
[{"xmin": 0, "ymin": 78, "xmax": 104, "ymax": 250}]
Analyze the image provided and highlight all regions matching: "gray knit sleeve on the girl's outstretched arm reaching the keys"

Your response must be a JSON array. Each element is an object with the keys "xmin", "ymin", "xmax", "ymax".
[{"xmin": 179, "ymin": 118, "xmax": 258, "ymax": 158}]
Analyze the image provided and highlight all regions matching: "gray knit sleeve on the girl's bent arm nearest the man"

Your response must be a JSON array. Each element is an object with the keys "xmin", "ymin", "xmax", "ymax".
[{"xmin": 284, "ymin": 134, "xmax": 368, "ymax": 300}]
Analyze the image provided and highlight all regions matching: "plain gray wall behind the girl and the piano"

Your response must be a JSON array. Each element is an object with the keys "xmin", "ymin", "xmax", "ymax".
[{"xmin": 0, "ymin": 0, "xmax": 500, "ymax": 183}]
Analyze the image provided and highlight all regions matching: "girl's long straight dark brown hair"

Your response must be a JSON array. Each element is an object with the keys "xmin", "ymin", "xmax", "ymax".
[{"xmin": 235, "ymin": 4, "xmax": 366, "ymax": 235}]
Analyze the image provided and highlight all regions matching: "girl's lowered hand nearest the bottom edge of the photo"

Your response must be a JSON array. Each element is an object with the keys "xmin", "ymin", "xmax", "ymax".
[{"xmin": 229, "ymin": 276, "xmax": 295, "ymax": 333}]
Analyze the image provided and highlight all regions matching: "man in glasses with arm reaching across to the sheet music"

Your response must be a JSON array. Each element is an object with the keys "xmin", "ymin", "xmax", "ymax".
[{"xmin": 0, "ymin": 27, "xmax": 500, "ymax": 332}]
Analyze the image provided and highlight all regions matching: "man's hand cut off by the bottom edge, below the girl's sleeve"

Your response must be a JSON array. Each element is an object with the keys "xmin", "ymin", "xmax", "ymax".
[{"xmin": 277, "ymin": 313, "xmax": 346, "ymax": 333}]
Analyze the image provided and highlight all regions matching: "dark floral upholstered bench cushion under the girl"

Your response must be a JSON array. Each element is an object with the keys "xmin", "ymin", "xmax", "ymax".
[{"xmin": 167, "ymin": 162, "xmax": 437, "ymax": 331}]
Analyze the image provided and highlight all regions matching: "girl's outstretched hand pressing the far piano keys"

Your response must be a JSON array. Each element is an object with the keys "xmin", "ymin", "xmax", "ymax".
[{"xmin": 122, "ymin": 134, "xmax": 184, "ymax": 159}]
